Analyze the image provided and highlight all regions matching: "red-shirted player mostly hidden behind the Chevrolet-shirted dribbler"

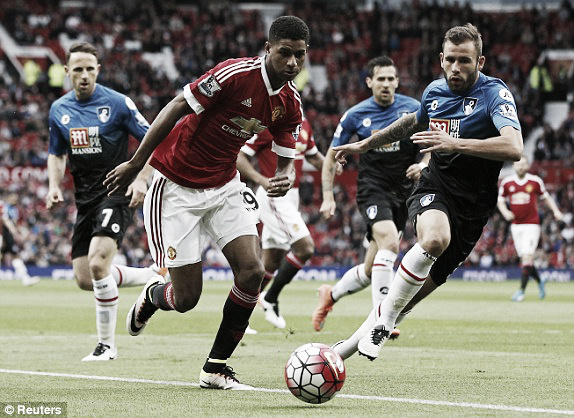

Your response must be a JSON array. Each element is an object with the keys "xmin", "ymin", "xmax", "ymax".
[{"xmin": 237, "ymin": 119, "xmax": 324, "ymax": 328}]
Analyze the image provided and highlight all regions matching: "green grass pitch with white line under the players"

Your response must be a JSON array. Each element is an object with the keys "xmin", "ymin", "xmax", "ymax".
[{"xmin": 0, "ymin": 280, "xmax": 574, "ymax": 418}]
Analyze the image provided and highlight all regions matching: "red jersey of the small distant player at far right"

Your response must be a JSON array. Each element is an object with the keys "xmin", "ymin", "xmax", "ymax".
[{"xmin": 498, "ymin": 173, "xmax": 548, "ymax": 224}]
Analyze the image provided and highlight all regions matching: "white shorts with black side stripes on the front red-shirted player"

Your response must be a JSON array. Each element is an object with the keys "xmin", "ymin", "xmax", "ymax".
[{"xmin": 143, "ymin": 170, "xmax": 259, "ymax": 267}]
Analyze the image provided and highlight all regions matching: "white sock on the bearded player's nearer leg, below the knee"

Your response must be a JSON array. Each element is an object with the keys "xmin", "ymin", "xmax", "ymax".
[{"xmin": 377, "ymin": 243, "xmax": 436, "ymax": 330}]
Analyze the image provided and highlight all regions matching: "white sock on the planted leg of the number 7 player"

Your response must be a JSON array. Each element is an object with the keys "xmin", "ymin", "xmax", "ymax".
[{"xmin": 92, "ymin": 274, "xmax": 119, "ymax": 347}]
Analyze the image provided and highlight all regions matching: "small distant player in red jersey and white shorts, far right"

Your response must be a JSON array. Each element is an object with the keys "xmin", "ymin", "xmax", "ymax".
[{"xmin": 498, "ymin": 155, "xmax": 562, "ymax": 302}]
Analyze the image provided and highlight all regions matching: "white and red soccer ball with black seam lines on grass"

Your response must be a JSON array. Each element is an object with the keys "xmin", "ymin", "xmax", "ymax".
[{"xmin": 285, "ymin": 343, "xmax": 346, "ymax": 404}]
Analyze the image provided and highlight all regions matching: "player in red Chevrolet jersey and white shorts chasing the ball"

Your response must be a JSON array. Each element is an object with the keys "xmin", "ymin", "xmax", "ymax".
[{"xmin": 105, "ymin": 16, "xmax": 309, "ymax": 390}]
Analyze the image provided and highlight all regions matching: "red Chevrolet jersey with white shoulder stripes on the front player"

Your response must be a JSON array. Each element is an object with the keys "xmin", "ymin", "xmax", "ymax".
[{"xmin": 150, "ymin": 57, "xmax": 303, "ymax": 189}]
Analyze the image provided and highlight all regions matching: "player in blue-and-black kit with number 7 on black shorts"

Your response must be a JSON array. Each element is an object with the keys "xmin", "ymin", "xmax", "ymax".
[{"xmin": 46, "ymin": 42, "xmax": 165, "ymax": 361}]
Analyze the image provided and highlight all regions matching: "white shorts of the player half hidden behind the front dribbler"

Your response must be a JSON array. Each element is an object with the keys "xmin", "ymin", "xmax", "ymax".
[{"xmin": 257, "ymin": 187, "xmax": 310, "ymax": 251}]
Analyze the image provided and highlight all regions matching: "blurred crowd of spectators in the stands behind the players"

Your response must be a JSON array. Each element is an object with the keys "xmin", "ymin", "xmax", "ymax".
[{"xmin": 0, "ymin": 0, "xmax": 574, "ymax": 268}]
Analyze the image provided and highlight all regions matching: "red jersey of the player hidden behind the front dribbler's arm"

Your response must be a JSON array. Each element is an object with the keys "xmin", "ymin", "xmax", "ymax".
[{"xmin": 241, "ymin": 119, "xmax": 319, "ymax": 188}]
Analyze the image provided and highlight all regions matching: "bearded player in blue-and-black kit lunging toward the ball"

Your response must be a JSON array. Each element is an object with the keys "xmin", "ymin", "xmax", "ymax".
[{"xmin": 335, "ymin": 23, "xmax": 523, "ymax": 360}]
